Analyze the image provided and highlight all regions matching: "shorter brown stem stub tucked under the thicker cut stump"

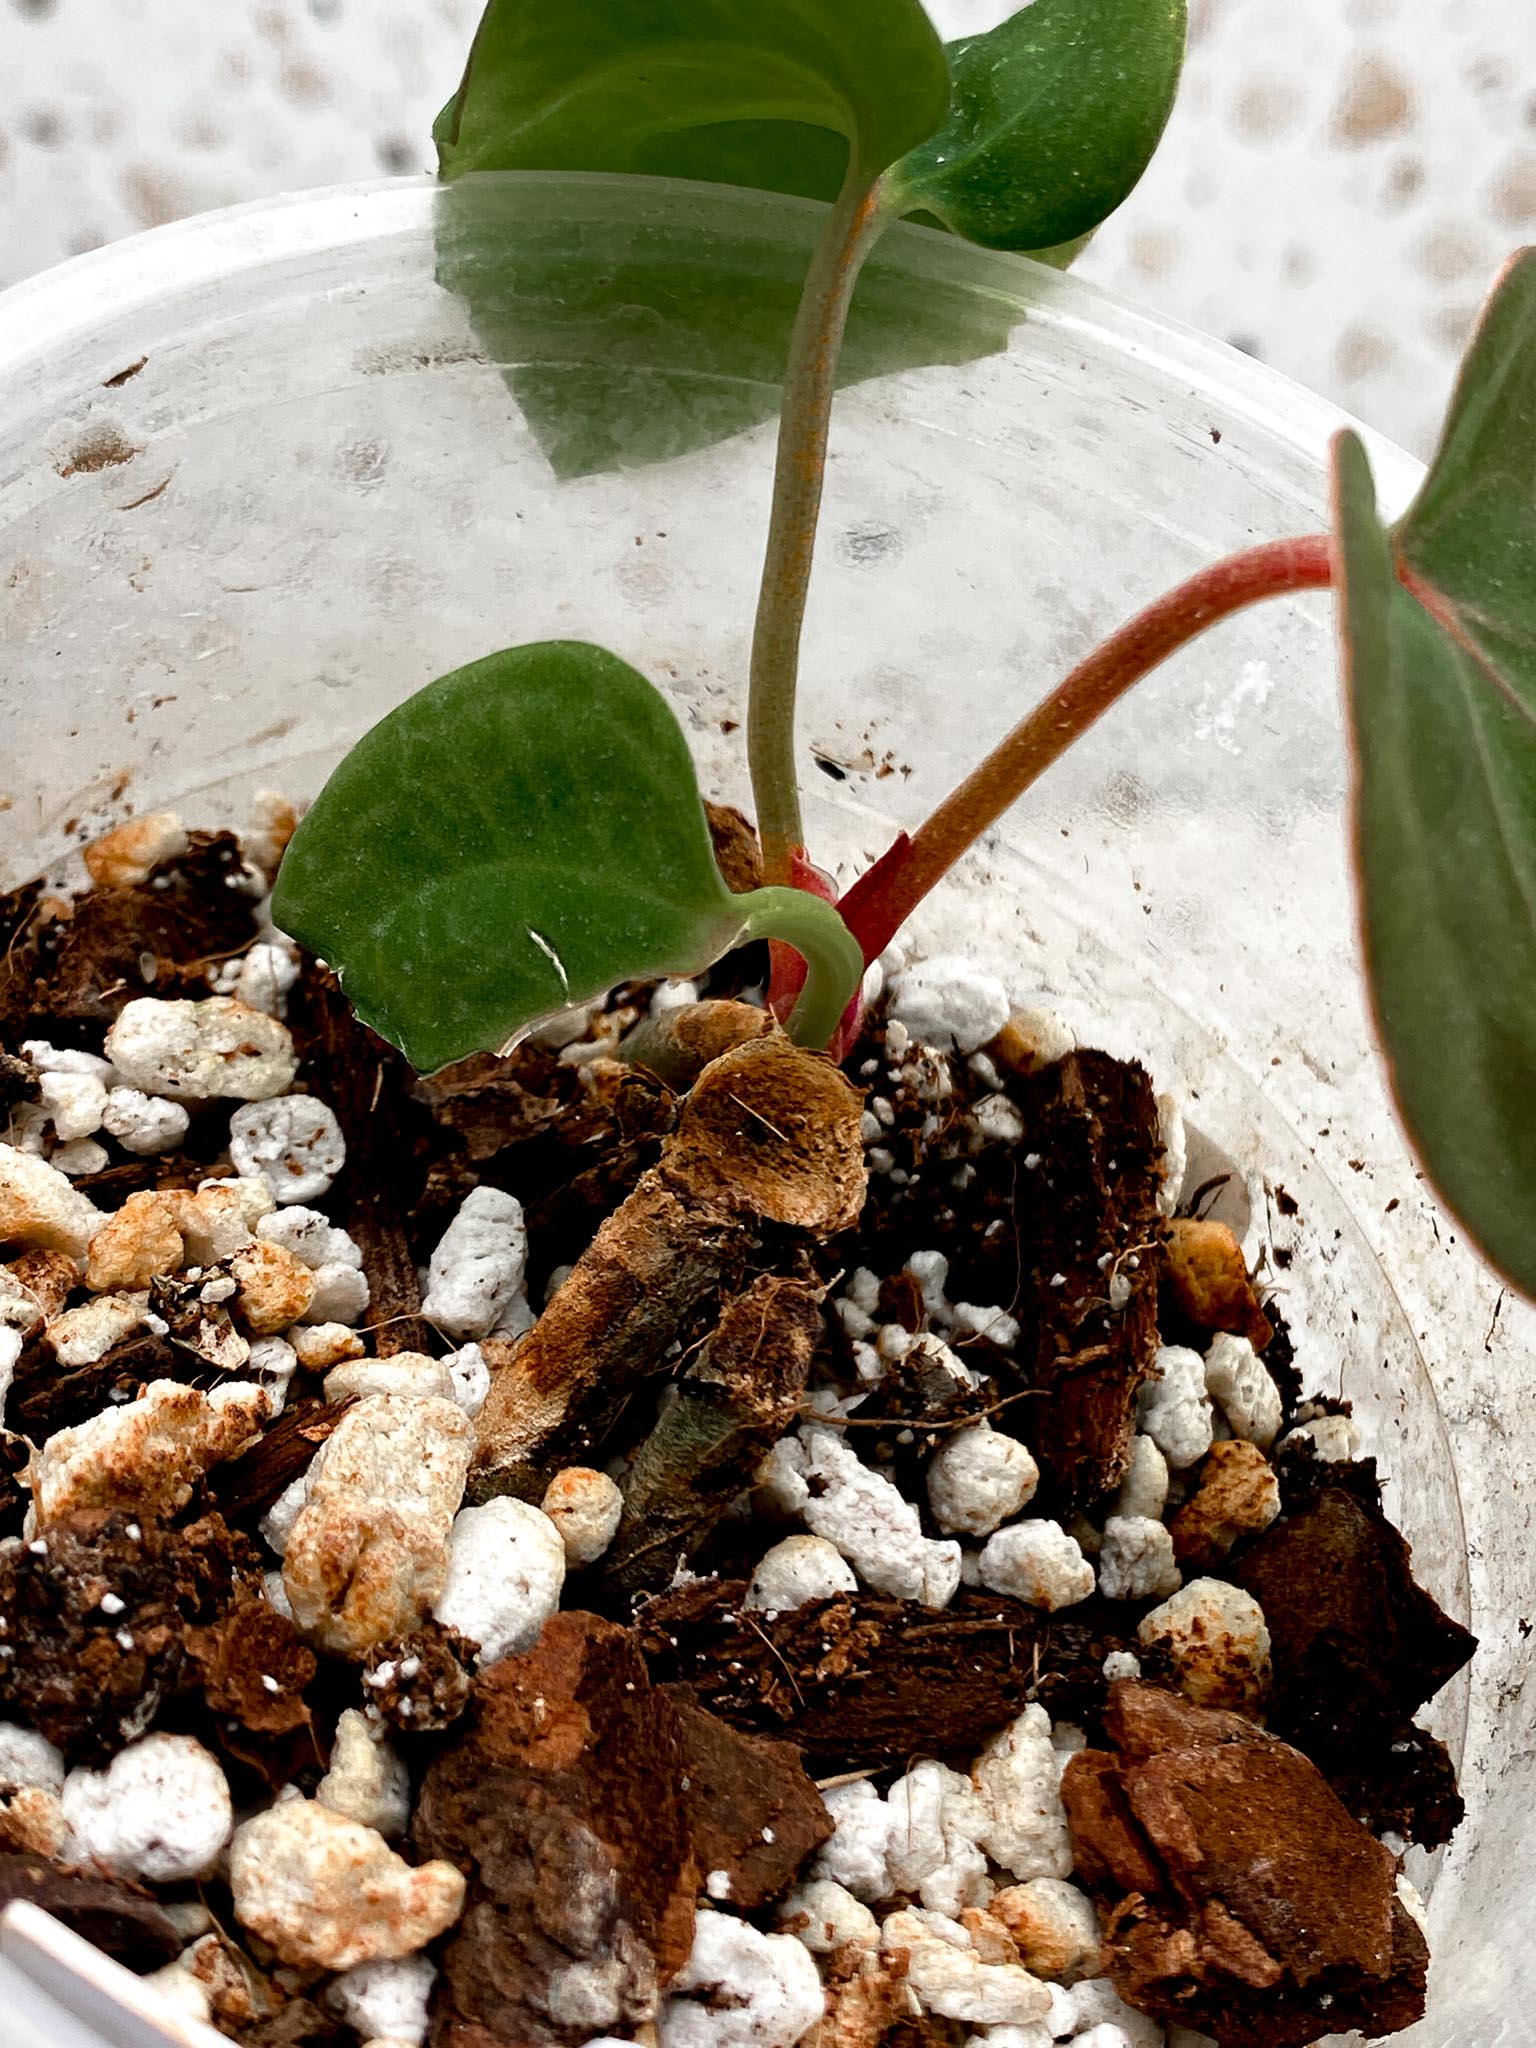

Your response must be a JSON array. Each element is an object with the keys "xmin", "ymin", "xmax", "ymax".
[{"xmin": 602, "ymin": 1274, "xmax": 823, "ymax": 1593}]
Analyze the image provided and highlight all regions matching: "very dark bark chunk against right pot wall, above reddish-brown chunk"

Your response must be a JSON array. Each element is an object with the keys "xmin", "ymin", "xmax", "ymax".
[{"xmin": 1231, "ymin": 1485, "xmax": 1477, "ymax": 1845}]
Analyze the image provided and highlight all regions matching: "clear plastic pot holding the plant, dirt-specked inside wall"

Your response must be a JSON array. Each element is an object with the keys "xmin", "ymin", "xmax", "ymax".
[{"xmin": 0, "ymin": 176, "xmax": 1536, "ymax": 2048}]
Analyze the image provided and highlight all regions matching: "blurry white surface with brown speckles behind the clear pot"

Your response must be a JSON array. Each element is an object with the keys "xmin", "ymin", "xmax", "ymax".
[{"xmin": 0, "ymin": 0, "xmax": 1536, "ymax": 453}]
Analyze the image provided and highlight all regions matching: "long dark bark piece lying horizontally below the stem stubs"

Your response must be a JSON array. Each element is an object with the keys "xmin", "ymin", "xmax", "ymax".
[{"xmin": 637, "ymin": 1579, "xmax": 1126, "ymax": 1776}]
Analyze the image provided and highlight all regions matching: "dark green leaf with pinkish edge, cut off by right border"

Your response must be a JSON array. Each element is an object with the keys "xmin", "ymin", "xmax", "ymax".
[{"xmin": 1335, "ymin": 250, "xmax": 1536, "ymax": 1292}]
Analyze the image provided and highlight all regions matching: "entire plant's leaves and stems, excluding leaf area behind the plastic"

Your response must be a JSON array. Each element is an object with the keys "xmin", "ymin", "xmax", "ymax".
[{"xmin": 274, "ymin": 0, "xmax": 1536, "ymax": 1290}]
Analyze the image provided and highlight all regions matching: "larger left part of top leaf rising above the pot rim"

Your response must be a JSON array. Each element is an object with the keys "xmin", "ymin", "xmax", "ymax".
[{"xmin": 432, "ymin": 0, "xmax": 948, "ymax": 193}]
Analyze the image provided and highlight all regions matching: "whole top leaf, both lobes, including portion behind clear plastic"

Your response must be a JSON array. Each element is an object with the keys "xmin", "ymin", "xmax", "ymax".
[{"xmin": 434, "ymin": 0, "xmax": 1184, "ymax": 475}]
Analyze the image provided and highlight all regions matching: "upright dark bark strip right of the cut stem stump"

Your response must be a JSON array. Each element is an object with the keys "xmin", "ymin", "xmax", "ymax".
[{"xmin": 1014, "ymin": 1051, "xmax": 1165, "ymax": 1511}]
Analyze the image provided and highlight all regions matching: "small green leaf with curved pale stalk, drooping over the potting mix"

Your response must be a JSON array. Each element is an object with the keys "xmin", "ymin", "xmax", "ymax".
[{"xmin": 272, "ymin": 641, "xmax": 862, "ymax": 1073}]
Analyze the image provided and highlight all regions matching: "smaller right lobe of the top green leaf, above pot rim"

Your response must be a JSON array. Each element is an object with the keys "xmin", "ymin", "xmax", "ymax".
[{"xmin": 889, "ymin": 0, "xmax": 1186, "ymax": 250}]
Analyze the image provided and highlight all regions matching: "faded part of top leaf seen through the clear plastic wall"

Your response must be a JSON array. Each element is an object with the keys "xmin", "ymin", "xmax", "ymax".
[{"xmin": 436, "ymin": 176, "xmax": 1022, "ymax": 477}]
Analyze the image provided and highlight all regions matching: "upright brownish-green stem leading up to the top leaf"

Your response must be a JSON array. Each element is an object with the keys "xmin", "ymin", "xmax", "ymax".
[{"xmin": 748, "ymin": 154, "xmax": 887, "ymax": 883}]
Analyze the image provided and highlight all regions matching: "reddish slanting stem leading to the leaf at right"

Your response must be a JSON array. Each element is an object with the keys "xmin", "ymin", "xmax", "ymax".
[{"xmin": 842, "ymin": 535, "xmax": 1331, "ymax": 961}]
